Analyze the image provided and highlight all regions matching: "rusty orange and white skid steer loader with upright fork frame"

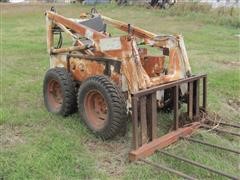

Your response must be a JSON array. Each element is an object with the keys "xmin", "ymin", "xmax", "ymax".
[{"xmin": 43, "ymin": 9, "xmax": 207, "ymax": 161}]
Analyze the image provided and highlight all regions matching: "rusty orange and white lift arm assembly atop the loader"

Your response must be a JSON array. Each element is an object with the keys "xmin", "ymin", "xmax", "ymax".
[{"xmin": 46, "ymin": 11, "xmax": 191, "ymax": 93}]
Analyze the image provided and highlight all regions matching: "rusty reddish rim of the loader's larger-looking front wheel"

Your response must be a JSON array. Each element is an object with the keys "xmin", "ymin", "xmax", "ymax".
[{"xmin": 84, "ymin": 90, "xmax": 108, "ymax": 129}]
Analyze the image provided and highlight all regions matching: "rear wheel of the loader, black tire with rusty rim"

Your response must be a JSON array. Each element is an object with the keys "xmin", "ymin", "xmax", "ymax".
[{"xmin": 43, "ymin": 68, "xmax": 77, "ymax": 116}]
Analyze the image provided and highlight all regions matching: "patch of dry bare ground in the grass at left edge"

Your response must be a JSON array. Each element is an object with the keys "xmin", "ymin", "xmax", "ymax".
[{"xmin": 0, "ymin": 125, "xmax": 24, "ymax": 148}]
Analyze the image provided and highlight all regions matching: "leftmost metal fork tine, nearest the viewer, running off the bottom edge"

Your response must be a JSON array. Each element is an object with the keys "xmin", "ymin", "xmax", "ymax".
[{"xmin": 140, "ymin": 159, "xmax": 196, "ymax": 180}]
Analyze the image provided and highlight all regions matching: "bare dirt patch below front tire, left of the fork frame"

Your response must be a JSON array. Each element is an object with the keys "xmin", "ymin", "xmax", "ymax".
[{"xmin": 85, "ymin": 137, "xmax": 130, "ymax": 177}]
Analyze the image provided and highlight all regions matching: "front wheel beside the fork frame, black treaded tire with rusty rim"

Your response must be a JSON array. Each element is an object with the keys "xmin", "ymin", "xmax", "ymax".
[{"xmin": 78, "ymin": 76, "xmax": 127, "ymax": 140}]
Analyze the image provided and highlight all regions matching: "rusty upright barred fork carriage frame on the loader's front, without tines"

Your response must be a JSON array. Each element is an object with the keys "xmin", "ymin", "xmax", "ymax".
[{"xmin": 129, "ymin": 75, "xmax": 207, "ymax": 161}]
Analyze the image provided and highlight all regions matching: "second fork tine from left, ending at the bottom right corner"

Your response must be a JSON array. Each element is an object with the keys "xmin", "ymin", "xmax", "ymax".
[{"xmin": 158, "ymin": 150, "xmax": 238, "ymax": 180}]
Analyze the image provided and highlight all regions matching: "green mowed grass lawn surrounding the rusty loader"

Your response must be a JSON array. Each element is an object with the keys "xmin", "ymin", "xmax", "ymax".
[{"xmin": 0, "ymin": 4, "xmax": 240, "ymax": 179}]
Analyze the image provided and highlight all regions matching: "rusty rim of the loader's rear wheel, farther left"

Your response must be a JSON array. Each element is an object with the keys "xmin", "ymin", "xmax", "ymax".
[{"xmin": 47, "ymin": 80, "xmax": 63, "ymax": 111}]
